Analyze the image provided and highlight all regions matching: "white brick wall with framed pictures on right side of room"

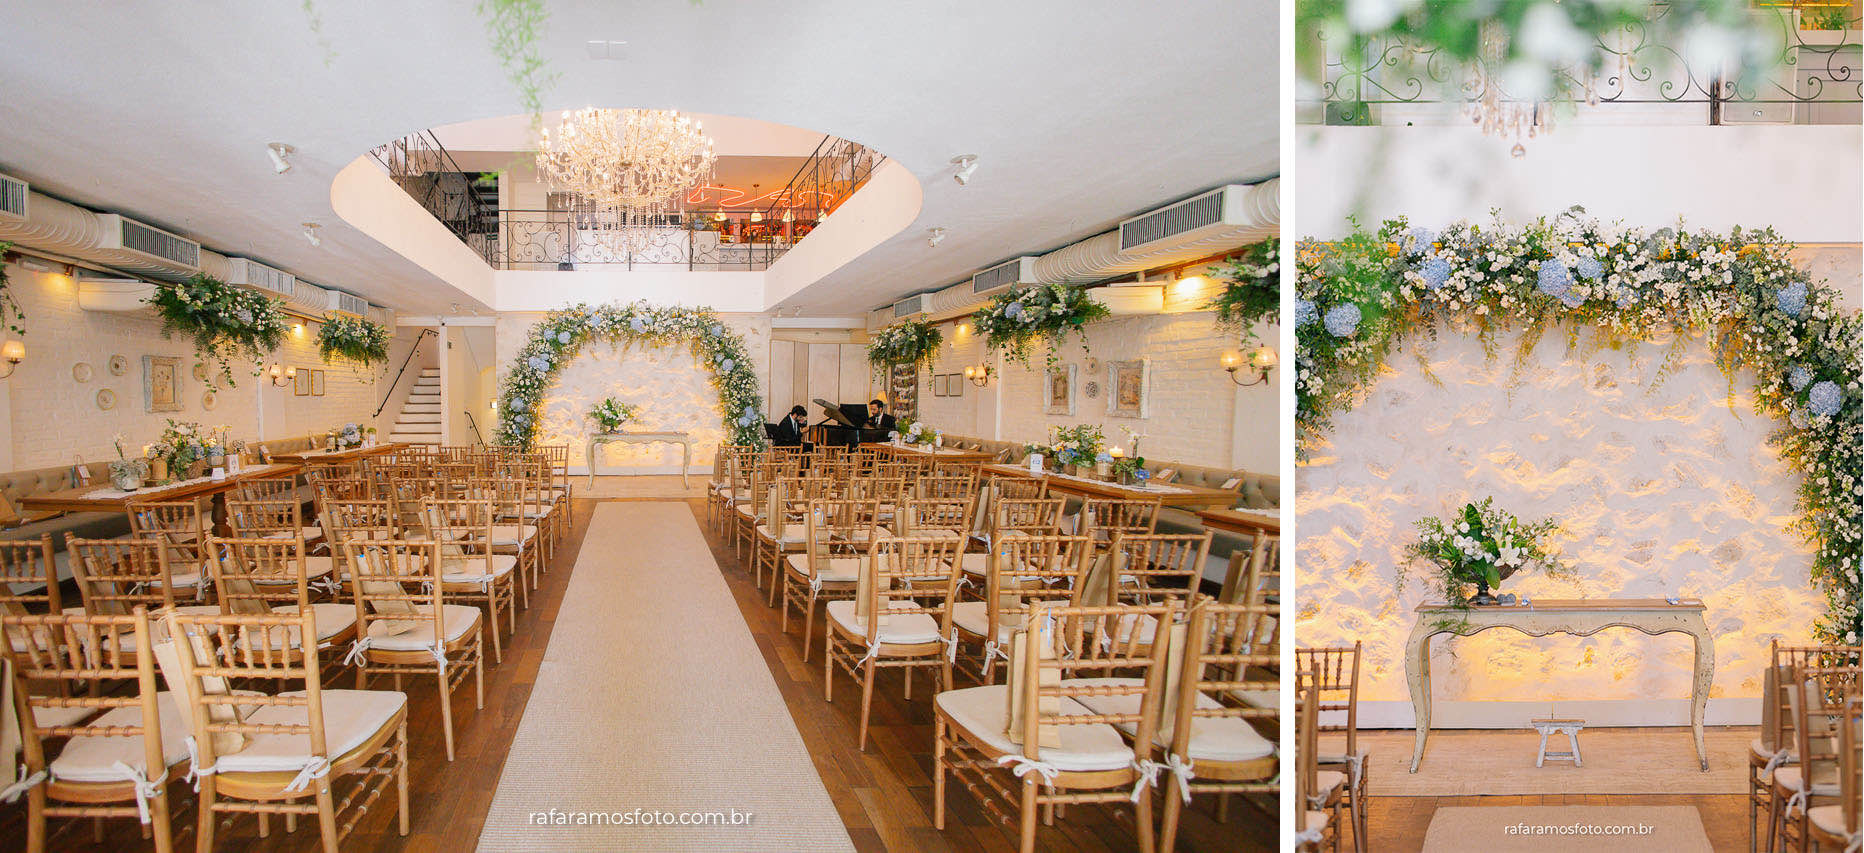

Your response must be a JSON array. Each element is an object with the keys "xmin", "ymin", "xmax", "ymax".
[{"xmin": 905, "ymin": 292, "xmax": 1281, "ymax": 473}]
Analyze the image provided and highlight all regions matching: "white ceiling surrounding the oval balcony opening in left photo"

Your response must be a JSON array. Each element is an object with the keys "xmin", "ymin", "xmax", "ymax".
[{"xmin": 0, "ymin": 0, "xmax": 1279, "ymax": 313}]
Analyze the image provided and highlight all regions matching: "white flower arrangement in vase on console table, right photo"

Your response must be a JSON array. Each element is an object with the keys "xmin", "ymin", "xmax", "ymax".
[{"xmin": 1398, "ymin": 497, "xmax": 1573, "ymax": 609}]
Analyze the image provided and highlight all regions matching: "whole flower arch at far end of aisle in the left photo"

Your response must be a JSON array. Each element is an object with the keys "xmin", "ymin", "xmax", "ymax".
[{"xmin": 496, "ymin": 302, "xmax": 764, "ymax": 456}]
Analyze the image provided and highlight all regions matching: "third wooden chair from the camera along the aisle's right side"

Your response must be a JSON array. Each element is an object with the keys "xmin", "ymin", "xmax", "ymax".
[{"xmin": 783, "ymin": 499, "xmax": 880, "ymax": 661}]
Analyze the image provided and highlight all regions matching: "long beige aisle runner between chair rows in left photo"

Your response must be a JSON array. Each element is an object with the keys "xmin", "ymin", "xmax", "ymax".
[{"xmin": 479, "ymin": 503, "xmax": 854, "ymax": 851}]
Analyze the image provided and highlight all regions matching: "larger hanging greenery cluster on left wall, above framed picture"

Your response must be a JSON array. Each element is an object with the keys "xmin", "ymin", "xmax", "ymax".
[{"xmin": 147, "ymin": 272, "xmax": 285, "ymax": 387}]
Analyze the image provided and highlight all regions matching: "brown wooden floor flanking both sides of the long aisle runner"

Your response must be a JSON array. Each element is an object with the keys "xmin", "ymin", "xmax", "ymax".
[{"xmin": 0, "ymin": 499, "xmax": 1274, "ymax": 853}]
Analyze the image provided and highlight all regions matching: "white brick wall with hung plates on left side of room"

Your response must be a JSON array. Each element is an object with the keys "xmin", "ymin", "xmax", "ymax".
[{"xmin": 4, "ymin": 264, "xmax": 408, "ymax": 469}]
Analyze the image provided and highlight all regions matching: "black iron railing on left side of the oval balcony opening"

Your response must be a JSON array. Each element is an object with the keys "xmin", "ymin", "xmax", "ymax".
[{"xmin": 369, "ymin": 130, "xmax": 498, "ymax": 263}]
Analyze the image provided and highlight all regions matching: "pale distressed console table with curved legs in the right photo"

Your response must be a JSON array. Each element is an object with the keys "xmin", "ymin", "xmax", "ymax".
[{"xmin": 1404, "ymin": 598, "xmax": 1715, "ymax": 773}]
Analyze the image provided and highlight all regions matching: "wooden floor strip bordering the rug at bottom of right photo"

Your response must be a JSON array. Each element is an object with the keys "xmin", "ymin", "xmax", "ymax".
[{"xmin": 1364, "ymin": 793, "xmax": 1767, "ymax": 853}]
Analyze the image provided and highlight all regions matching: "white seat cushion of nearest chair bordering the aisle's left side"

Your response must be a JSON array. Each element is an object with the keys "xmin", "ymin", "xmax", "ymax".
[{"xmin": 217, "ymin": 689, "xmax": 408, "ymax": 773}]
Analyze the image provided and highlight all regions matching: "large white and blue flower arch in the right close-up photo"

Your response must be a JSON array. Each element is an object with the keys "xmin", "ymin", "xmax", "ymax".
[{"xmin": 1295, "ymin": 209, "xmax": 1864, "ymax": 644}]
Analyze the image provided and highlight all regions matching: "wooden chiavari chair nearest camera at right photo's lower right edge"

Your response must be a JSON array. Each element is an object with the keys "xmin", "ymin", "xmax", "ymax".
[{"xmin": 1767, "ymin": 665, "xmax": 1858, "ymax": 853}]
